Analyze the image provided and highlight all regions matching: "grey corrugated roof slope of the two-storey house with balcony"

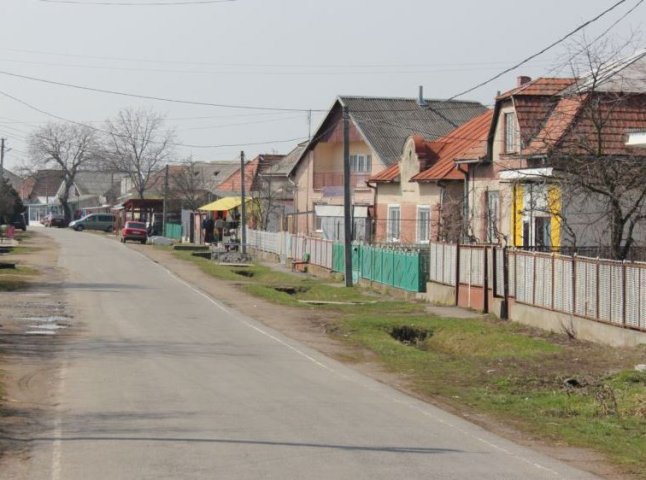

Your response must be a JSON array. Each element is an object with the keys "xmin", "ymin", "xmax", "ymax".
[{"xmin": 339, "ymin": 96, "xmax": 487, "ymax": 165}]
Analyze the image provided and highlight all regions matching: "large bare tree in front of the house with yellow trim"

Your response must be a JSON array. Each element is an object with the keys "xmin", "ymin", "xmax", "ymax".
[{"xmin": 544, "ymin": 42, "xmax": 646, "ymax": 259}]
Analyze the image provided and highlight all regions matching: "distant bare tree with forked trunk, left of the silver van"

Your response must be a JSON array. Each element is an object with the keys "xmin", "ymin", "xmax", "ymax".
[{"xmin": 29, "ymin": 123, "xmax": 99, "ymax": 222}]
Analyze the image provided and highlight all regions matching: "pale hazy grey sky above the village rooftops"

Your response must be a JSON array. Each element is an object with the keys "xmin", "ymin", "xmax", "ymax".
[{"xmin": 0, "ymin": 0, "xmax": 646, "ymax": 170}]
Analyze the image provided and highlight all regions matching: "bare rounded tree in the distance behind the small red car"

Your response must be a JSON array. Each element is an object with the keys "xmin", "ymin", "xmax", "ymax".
[{"xmin": 105, "ymin": 108, "xmax": 175, "ymax": 199}]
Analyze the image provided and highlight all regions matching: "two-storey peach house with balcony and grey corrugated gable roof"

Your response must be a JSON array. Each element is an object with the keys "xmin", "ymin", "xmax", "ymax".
[{"xmin": 290, "ymin": 89, "xmax": 486, "ymax": 241}]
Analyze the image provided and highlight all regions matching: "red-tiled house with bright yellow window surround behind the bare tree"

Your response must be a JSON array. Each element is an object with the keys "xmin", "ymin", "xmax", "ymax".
[{"xmin": 463, "ymin": 51, "xmax": 646, "ymax": 250}]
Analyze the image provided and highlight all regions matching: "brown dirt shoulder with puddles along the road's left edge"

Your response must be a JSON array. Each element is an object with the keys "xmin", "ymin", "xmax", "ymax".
[{"xmin": 0, "ymin": 231, "xmax": 74, "ymax": 478}]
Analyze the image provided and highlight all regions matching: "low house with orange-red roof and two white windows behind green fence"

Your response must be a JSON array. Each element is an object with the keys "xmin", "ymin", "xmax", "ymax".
[{"xmin": 369, "ymin": 110, "xmax": 493, "ymax": 244}]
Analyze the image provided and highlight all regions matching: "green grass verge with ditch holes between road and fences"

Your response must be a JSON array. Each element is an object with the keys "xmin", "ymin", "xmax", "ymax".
[{"xmin": 166, "ymin": 252, "xmax": 646, "ymax": 479}]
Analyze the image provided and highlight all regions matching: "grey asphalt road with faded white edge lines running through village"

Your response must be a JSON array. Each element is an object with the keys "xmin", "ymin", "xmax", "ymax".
[{"xmin": 7, "ymin": 230, "xmax": 596, "ymax": 480}]
